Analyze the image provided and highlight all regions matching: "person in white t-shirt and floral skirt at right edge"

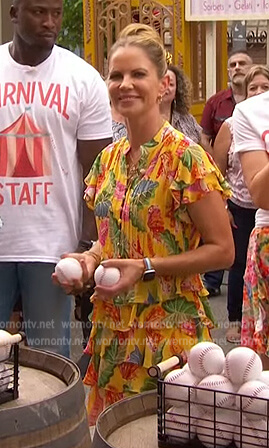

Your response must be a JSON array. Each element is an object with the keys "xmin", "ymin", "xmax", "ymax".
[{"xmin": 234, "ymin": 71, "xmax": 269, "ymax": 370}]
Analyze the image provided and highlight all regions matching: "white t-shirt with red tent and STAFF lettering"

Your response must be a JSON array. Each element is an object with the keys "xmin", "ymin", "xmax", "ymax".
[{"xmin": 0, "ymin": 44, "xmax": 112, "ymax": 262}]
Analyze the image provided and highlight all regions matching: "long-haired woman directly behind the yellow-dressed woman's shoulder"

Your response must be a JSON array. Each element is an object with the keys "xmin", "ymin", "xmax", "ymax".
[{"xmin": 160, "ymin": 65, "xmax": 202, "ymax": 143}]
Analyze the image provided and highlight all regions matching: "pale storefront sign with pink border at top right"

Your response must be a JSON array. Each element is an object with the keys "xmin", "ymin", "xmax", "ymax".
[{"xmin": 185, "ymin": 0, "xmax": 269, "ymax": 21}]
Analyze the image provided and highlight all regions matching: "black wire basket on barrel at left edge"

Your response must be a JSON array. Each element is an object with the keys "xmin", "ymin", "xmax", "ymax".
[{"xmin": 0, "ymin": 343, "xmax": 19, "ymax": 404}]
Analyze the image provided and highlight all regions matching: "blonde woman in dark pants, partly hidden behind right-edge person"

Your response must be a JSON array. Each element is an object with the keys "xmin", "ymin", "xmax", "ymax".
[{"xmin": 213, "ymin": 65, "xmax": 269, "ymax": 342}]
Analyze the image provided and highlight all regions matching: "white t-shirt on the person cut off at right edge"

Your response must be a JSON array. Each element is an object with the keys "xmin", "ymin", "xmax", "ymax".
[{"xmin": 233, "ymin": 92, "xmax": 269, "ymax": 227}]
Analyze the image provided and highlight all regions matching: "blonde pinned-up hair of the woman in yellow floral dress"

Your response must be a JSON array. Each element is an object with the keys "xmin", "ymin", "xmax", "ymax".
[{"xmin": 108, "ymin": 23, "xmax": 167, "ymax": 79}]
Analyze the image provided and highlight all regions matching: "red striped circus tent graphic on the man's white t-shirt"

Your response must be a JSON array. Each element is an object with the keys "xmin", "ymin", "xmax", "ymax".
[{"xmin": 0, "ymin": 112, "xmax": 51, "ymax": 177}]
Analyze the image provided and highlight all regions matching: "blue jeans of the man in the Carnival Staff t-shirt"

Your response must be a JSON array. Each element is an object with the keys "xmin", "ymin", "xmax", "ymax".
[{"xmin": 0, "ymin": 262, "xmax": 71, "ymax": 357}]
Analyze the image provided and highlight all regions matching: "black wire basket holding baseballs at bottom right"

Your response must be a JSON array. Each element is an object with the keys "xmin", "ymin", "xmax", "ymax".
[{"xmin": 149, "ymin": 356, "xmax": 269, "ymax": 448}]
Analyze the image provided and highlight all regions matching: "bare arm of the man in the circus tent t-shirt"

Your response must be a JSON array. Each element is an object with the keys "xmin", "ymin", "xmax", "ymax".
[{"xmin": 77, "ymin": 138, "xmax": 112, "ymax": 250}]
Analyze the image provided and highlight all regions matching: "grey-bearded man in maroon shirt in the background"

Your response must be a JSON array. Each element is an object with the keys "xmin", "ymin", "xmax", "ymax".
[{"xmin": 201, "ymin": 50, "xmax": 252, "ymax": 297}]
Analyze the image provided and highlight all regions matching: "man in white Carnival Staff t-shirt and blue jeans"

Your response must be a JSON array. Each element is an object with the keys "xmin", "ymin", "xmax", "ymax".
[{"xmin": 0, "ymin": 0, "xmax": 112, "ymax": 356}]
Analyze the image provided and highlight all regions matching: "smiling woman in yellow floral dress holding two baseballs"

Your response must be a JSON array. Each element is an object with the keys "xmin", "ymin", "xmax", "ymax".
[{"xmin": 55, "ymin": 24, "xmax": 233, "ymax": 425}]
